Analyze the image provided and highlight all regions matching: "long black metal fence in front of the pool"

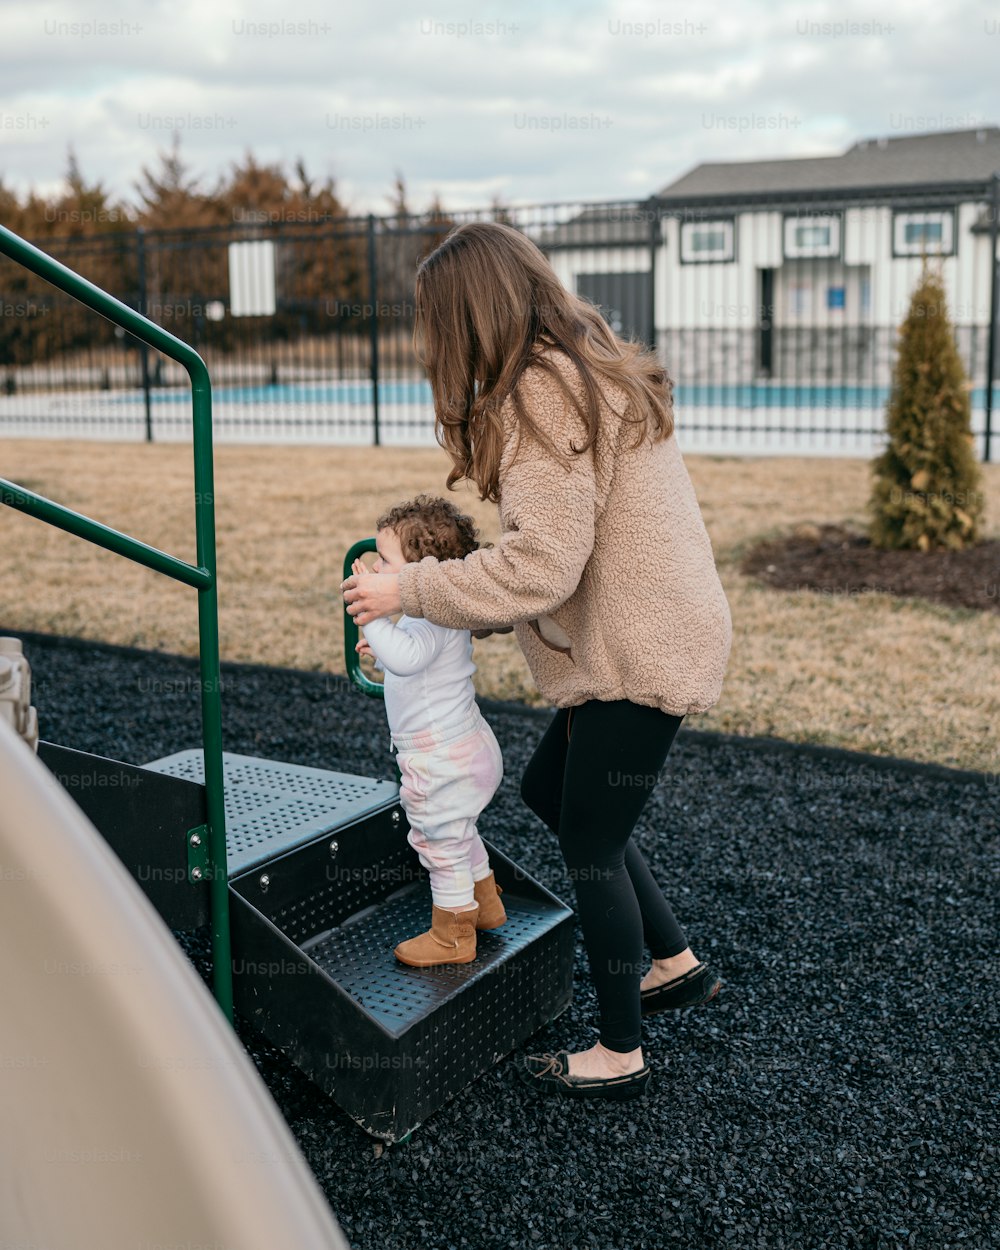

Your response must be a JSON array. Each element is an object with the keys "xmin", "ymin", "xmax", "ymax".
[{"xmin": 0, "ymin": 178, "xmax": 1000, "ymax": 459}]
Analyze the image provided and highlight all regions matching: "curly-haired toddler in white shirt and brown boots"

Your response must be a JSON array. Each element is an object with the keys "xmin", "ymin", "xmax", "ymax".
[{"xmin": 351, "ymin": 495, "xmax": 506, "ymax": 968}]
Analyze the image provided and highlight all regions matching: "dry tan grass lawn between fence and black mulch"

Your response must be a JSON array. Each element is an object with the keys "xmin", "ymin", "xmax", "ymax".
[{"xmin": 0, "ymin": 440, "xmax": 1000, "ymax": 771}]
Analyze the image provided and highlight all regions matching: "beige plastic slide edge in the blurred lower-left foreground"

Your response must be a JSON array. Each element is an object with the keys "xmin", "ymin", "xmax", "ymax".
[{"xmin": 0, "ymin": 719, "xmax": 348, "ymax": 1250}]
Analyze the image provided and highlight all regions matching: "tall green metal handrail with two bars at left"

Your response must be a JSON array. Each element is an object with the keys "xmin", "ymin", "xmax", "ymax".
[{"xmin": 0, "ymin": 226, "xmax": 233, "ymax": 1023}]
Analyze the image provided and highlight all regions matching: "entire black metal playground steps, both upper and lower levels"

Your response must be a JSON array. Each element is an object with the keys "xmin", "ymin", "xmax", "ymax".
[{"xmin": 39, "ymin": 743, "xmax": 575, "ymax": 1141}]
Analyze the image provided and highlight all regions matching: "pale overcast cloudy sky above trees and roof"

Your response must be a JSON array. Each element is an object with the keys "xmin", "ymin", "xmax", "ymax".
[{"xmin": 0, "ymin": 0, "xmax": 1000, "ymax": 211}]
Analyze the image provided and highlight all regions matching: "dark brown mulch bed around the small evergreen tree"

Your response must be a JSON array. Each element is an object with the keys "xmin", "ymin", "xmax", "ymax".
[{"xmin": 740, "ymin": 525, "xmax": 1000, "ymax": 613}]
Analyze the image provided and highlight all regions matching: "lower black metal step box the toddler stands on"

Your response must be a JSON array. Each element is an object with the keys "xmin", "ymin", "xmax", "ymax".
[{"xmin": 230, "ymin": 810, "xmax": 575, "ymax": 1141}]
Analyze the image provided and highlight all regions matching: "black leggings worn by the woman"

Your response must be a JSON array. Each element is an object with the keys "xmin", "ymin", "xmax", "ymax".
[{"xmin": 521, "ymin": 699, "xmax": 688, "ymax": 1053}]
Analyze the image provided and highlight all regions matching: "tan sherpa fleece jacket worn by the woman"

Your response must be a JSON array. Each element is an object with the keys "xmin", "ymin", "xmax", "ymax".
[{"xmin": 399, "ymin": 351, "xmax": 733, "ymax": 716}]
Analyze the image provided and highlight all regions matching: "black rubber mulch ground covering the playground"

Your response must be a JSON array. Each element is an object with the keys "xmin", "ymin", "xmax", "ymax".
[{"xmin": 11, "ymin": 635, "xmax": 1000, "ymax": 1250}]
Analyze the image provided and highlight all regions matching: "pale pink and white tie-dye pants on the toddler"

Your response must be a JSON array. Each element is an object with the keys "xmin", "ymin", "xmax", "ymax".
[{"xmin": 393, "ymin": 709, "xmax": 504, "ymax": 908}]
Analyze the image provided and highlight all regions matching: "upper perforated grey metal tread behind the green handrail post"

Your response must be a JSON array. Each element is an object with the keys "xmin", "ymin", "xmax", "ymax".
[{"xmin": 144, "ymin": 750, "xmax": 399, "ymax": 878}]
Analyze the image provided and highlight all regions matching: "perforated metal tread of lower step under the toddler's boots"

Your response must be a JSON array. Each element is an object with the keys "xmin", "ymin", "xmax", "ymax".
[{"xmin": 301, "ymin": 881, "xmax": 561, "ymax": 1038}]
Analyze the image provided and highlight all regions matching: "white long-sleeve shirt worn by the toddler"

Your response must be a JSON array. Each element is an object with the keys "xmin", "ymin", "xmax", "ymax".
[{"xmin": 363, "ymin": 615, "xmax": 476, "ymax": 734}]
